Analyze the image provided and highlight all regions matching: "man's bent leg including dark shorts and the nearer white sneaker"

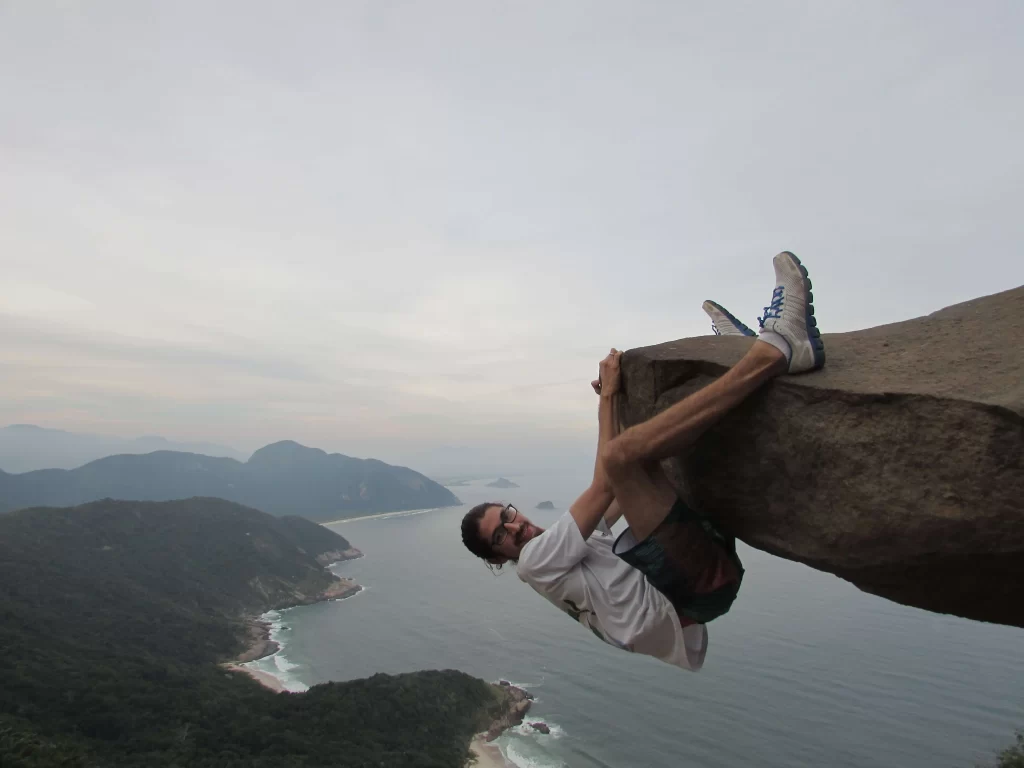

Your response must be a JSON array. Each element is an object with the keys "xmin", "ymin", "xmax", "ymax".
[{"xmin": 600, "ymin": 252, "xmax": 824, "ymax": 626}]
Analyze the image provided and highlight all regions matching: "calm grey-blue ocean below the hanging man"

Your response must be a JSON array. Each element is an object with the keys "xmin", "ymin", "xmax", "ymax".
[{"xmin": 245, "ymin": 473, "xmax": 1024, "ymax": 768}]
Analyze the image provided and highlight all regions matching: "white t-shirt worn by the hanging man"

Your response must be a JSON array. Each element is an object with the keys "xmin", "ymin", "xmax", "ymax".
[{"xmin": 517, "ymin": 512, "xmax": 708, "ymax": 672}]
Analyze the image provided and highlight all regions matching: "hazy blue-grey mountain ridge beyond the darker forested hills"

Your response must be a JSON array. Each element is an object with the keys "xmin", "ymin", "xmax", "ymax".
[{"xmin": 0, "ymin": 441, "xmax": 460, "ymax": 520}]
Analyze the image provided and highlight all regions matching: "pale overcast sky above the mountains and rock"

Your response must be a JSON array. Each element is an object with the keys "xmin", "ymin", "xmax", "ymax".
[{"xmin": 0, "ymin": 0, "xmax": 1024, "ymax": 474}]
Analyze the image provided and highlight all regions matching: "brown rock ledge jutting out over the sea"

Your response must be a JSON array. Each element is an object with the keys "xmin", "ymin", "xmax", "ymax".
[{"xmin": 621, "ymin": 287, "xmax": 1024, "ymax": 627}]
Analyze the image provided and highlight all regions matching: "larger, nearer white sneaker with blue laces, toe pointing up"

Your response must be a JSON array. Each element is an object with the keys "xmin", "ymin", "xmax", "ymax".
[{"xmin": 758, "ymin": 251, "xmax": 825, "ymax": 374}]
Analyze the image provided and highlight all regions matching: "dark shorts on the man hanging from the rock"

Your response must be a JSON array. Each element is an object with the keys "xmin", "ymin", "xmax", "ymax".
[{"xmin": 614, "ymin": 500, "xmax": 743, "ymax": 624}]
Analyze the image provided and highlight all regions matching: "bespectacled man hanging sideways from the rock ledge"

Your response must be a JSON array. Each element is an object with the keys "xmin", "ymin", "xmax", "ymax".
[{"xmin": 462, "ymin": 252, "xmax": 825, "ymax": 671}]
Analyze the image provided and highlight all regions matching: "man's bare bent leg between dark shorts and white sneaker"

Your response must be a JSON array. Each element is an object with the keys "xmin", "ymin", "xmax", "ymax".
[{"xmin": 601, "ymin": 341, "xmax": 787, "ymax": 541}]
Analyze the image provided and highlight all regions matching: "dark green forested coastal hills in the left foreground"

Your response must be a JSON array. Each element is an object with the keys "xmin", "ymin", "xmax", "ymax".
[{"xmin": 0, "ymin": 499, "xmax": 503, "ymax": 768}]
